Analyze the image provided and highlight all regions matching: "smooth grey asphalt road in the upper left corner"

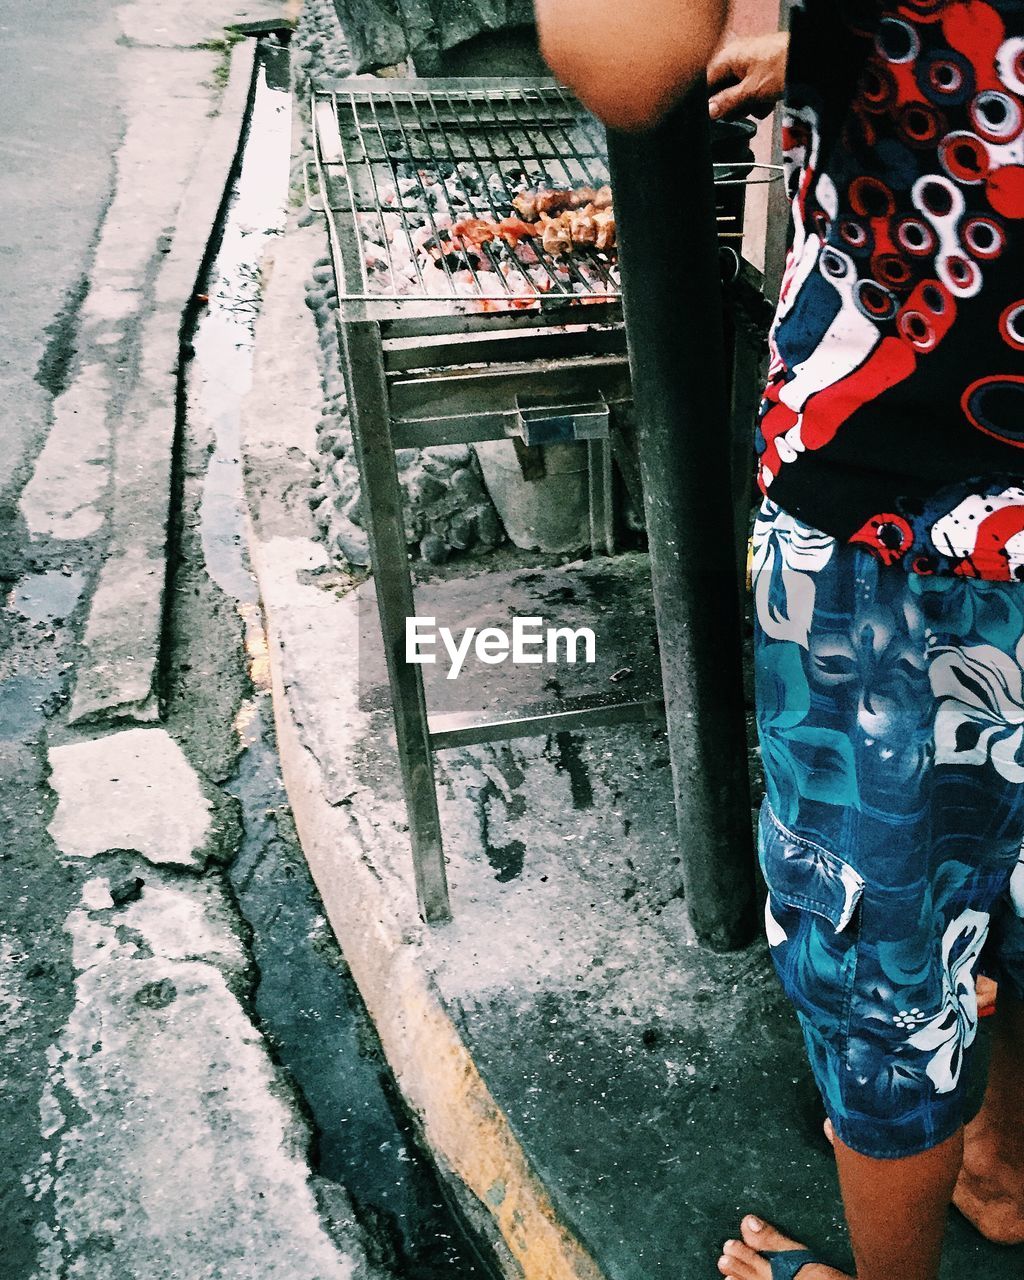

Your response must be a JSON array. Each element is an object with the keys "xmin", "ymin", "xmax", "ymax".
[{"xmin": 0, "ymin": 0, "xmax": 122, "ymax": 501}]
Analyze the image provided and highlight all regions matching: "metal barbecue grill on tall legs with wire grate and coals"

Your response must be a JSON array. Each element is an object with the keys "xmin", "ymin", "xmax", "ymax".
[{"xmin": 307, "ymin": 78, "xmax": 772, "ymax": 922}]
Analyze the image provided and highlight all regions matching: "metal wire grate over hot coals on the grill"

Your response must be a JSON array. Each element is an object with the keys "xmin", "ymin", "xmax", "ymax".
[{"xmin": 312, "ymin": 78, "xmax": 769, "ymax": 315}]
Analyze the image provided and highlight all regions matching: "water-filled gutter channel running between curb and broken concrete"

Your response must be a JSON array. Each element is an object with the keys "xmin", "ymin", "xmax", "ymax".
[{"xmin": 188, "ymin": 40, "xmax": 494, "ymax": 1280}]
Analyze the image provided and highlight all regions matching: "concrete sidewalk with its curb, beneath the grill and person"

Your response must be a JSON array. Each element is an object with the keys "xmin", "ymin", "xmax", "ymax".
[{"xmin": 243, "ymin": 199, "xmax": 1024, "ymax": 1280}]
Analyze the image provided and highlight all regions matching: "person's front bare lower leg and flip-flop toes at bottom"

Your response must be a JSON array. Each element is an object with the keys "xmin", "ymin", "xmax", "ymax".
[{"xmin": 718, "ymin": 1132, "xmax": 963, "ymax": 1280}]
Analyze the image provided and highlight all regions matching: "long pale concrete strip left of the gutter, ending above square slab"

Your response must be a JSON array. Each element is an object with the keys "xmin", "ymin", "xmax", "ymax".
[{"xmin": 64, "ymin": 42, "xmax": 253, "ymax": 722}]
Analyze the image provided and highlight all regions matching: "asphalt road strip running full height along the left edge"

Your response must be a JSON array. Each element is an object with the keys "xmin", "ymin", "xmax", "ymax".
[{"xmin": 0, "ymin": 0, "xmax": 122, "ymax": 1280}]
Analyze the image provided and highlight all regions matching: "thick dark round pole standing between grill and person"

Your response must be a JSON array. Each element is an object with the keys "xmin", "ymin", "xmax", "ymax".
[{"xmin": 608, "ymin": 84, "xmax": 755, "ymax": 951}]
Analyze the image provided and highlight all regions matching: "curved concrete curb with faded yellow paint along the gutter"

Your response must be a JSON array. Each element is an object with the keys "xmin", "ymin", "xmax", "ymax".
[{"xmin": 242, "ymin": 227, "xmax": 602, "ymax": 1280}]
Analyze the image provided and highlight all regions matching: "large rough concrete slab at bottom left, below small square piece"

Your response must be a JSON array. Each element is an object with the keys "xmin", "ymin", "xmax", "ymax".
[{"xmin": 31, "ymin": 873, "xmax": 356, "ymax": 1280}]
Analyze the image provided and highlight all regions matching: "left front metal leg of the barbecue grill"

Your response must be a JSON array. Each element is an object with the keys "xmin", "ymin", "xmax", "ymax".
[{"xmin": 340, "ymin": 320, "xmax": 452, "ymax": 924}]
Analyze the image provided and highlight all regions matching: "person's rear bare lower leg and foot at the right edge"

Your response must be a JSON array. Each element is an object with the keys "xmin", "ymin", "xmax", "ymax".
[{"xmin": 954, "ymin": 989, "xmax": 1024, "ymax": 1244}]
